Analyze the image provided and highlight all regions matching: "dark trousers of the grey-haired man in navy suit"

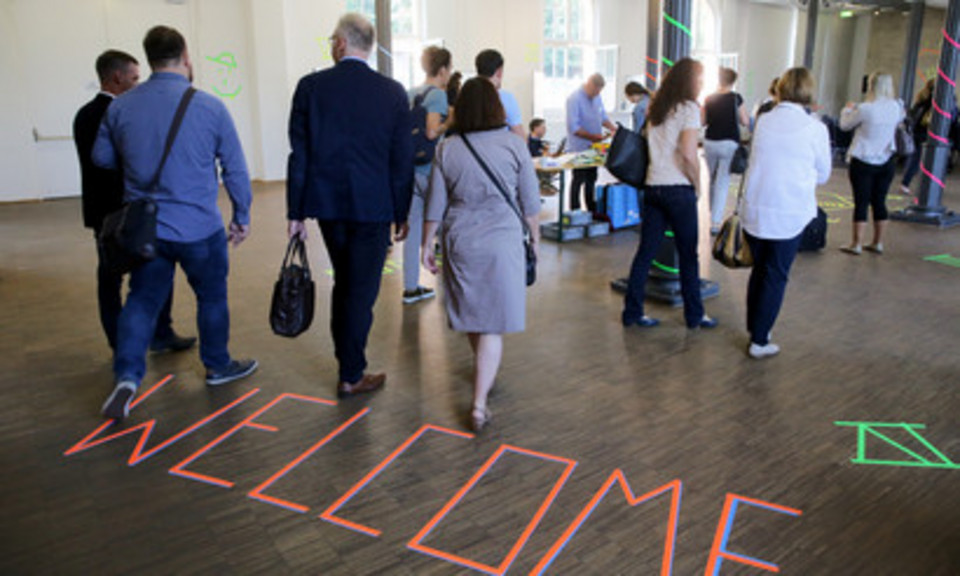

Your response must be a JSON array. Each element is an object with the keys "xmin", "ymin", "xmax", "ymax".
[{"xmin": 320, "ymin": 221, "xmax": 390, "ymax": 384}]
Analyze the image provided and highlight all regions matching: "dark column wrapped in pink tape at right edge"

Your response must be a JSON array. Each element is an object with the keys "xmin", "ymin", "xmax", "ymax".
[{"xmin": 892, "ymin": 0, "xmax": 960, "ymax": 228}]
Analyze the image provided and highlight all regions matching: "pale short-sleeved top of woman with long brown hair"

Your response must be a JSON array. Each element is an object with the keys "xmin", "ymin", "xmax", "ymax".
[{"xmin": 647, "ymin": 101, "xmax": 700, "ymax": 186}]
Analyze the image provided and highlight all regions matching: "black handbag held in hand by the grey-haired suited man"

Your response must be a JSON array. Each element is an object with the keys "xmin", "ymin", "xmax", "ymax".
[{"xmin": 270, "ymin": 236, "xmax": 316, "ymax": 338}]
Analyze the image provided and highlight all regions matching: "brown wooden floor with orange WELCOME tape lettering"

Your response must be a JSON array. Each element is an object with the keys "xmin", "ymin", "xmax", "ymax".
[{"xmin": 0, "ymin": 164, "xmax": 960, "ymax": 576}]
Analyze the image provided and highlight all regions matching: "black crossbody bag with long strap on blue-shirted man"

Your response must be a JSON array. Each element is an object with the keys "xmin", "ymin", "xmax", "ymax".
[{"xmin": 97, "ymin": 87, "xmax": 196, "ymax": 274}]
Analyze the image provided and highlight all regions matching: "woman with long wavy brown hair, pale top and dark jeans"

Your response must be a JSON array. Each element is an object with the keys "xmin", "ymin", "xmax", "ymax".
[{"xmin": 621, "ymin": 58, "xmax": 717, "ymax": 329}]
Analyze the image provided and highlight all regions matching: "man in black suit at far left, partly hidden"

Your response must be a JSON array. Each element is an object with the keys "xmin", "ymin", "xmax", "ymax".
[{"xmin": 73, "ymin": 50, "xmax": 196, "ymax": 352}]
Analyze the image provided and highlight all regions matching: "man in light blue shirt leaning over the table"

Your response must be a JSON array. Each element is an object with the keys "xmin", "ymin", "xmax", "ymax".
[{"xmin": 567, "ymin": 74, "xmax": 617, "ymax": 212}]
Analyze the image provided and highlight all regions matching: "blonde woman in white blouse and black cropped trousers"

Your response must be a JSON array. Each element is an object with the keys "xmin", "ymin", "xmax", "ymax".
[{"xmin": 840, "ymin": 72, "xmax": 904, "ymax": 255}]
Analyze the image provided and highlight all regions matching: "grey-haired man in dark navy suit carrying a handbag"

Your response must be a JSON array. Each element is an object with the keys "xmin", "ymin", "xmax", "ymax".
[{"xmin": 287, "ymin": 14, "xmax": 413, "ymax": 397}]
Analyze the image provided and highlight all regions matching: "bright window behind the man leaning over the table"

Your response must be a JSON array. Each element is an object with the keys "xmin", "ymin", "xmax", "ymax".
[{"xmin": 534, "ymin": 0, "xmax": 620, "ymax": 116}]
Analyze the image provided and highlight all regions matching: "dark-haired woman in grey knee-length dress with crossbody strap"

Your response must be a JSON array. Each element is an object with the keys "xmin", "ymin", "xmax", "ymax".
[{"xmin": 421, "ymin": 78, "xmax": 540, "ymax": 431}]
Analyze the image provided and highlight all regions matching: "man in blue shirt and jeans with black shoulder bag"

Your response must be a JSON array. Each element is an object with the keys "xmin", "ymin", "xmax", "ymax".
[{"xmin": 93, "ymin": 26, "xmax": 257, "ymax": 421}]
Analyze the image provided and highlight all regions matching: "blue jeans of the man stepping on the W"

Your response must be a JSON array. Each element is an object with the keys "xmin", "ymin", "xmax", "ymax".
[{"xmin": 113, "ymin": 230, "xmax": 230, "ymax": 384}]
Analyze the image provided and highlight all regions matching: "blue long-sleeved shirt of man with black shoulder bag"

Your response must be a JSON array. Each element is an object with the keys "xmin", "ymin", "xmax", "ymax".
[{"xmin": 93, "ymin": 72, "xmax": 253, "ymax": 242}]
